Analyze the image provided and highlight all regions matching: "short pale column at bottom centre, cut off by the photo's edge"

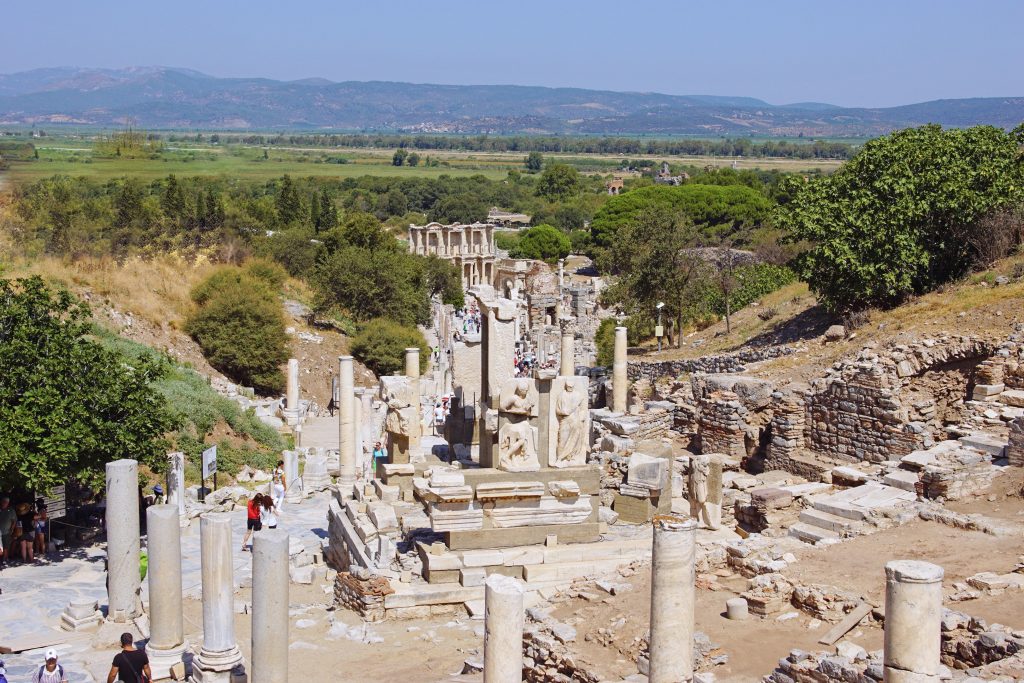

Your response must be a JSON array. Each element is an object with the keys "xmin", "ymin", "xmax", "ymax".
[{"xmin": 483, "ymin": 573, "xmax": 525, "ymax": 683}]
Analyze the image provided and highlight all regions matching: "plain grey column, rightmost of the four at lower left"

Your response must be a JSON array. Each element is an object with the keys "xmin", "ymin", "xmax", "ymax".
[{"xmin": 251, "ymin": 528, "xmax": 289, "ymax": 683}]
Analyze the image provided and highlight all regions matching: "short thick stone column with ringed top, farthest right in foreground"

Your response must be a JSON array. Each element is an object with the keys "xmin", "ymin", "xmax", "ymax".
[{"xmin": 884, "ymin": 560, "xmax": 943, "ymax": 683}]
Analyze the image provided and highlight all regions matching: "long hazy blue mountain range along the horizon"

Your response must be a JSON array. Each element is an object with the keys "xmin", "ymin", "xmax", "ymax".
[{"xmin": 0, "ymin": 67, "xmax": 1024, "ymax": 137}]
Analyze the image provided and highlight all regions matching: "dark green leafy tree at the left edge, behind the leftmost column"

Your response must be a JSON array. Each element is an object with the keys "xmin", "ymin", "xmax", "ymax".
[{"xmin": 0, "ymin": 278, "xmax": 174, "ymax": 490}]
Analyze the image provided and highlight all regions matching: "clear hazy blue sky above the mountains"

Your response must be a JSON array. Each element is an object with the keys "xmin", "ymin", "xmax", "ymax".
[{"xmin": 0, "ymin": 0, "xmax": 1024, "ymax": 106}]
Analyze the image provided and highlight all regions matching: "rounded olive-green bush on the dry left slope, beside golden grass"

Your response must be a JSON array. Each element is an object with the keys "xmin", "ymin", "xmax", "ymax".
[{"xmin": 185, "ymin": 266, "xmax": 288, "ymax": 393}]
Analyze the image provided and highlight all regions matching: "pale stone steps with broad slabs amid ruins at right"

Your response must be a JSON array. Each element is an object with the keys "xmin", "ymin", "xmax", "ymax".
[{"xmin": 790, "ymin": 482, "xmax": 916, "ymax": 544}]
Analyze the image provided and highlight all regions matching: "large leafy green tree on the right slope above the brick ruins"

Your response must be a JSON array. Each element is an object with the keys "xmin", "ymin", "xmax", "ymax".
[{"xmin": 776, "ymin": 126, "xmax": 1024, "ymax": 311}]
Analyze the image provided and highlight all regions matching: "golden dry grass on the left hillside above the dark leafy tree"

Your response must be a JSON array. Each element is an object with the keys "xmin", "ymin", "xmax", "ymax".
[{"xmin": 9, "ymin": 255, "xmax": 216, "ymax": 329}]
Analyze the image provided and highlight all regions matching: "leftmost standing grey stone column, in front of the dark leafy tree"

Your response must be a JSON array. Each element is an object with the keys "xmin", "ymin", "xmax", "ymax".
[{"xmin": 106, "ymin": 460, "xmax": 142, "ymax": 623}]
